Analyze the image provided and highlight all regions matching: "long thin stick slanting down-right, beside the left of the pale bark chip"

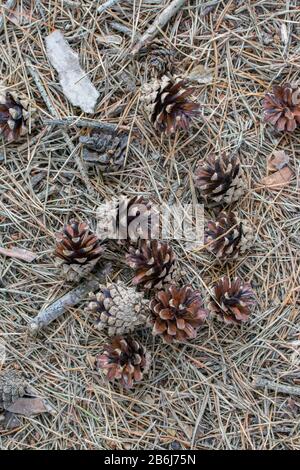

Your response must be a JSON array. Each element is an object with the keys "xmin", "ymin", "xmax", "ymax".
[{"xmin": 26, "ymin": 60, "xmax": 96, "ymax": 195}]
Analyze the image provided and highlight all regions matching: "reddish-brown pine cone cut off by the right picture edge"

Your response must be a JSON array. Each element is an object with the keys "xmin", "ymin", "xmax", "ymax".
[{"xmin": 263, "ymin": 83, "xmax": 300, "ymax": 132}]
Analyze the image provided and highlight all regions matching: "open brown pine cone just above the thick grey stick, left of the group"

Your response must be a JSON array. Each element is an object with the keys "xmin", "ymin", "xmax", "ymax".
[{"xmin": 54, "ymin": 219, "xmax": 103, "ymax": 282}]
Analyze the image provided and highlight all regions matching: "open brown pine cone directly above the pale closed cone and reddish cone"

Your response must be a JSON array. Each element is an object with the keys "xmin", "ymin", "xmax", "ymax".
[{"xmin": 126, "ymin": 240, "xmax": 177, "ymax": 290}]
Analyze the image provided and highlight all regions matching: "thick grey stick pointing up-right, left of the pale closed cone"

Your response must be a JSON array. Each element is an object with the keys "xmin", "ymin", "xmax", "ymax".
[{"xmin": 28, "ymin": 263, "xmax": 111, "ymax": 335}]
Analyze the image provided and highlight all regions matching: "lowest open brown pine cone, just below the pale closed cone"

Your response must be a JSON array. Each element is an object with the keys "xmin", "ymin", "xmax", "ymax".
[{"xmin": 95, "ymin": 336, "xmax": 150, "ymax": 388}]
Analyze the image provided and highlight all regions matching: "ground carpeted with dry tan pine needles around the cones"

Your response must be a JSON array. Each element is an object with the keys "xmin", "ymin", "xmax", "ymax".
[{"xmin": 0, "ymin": 0, "xmax": 300, "ymax": 449}]
